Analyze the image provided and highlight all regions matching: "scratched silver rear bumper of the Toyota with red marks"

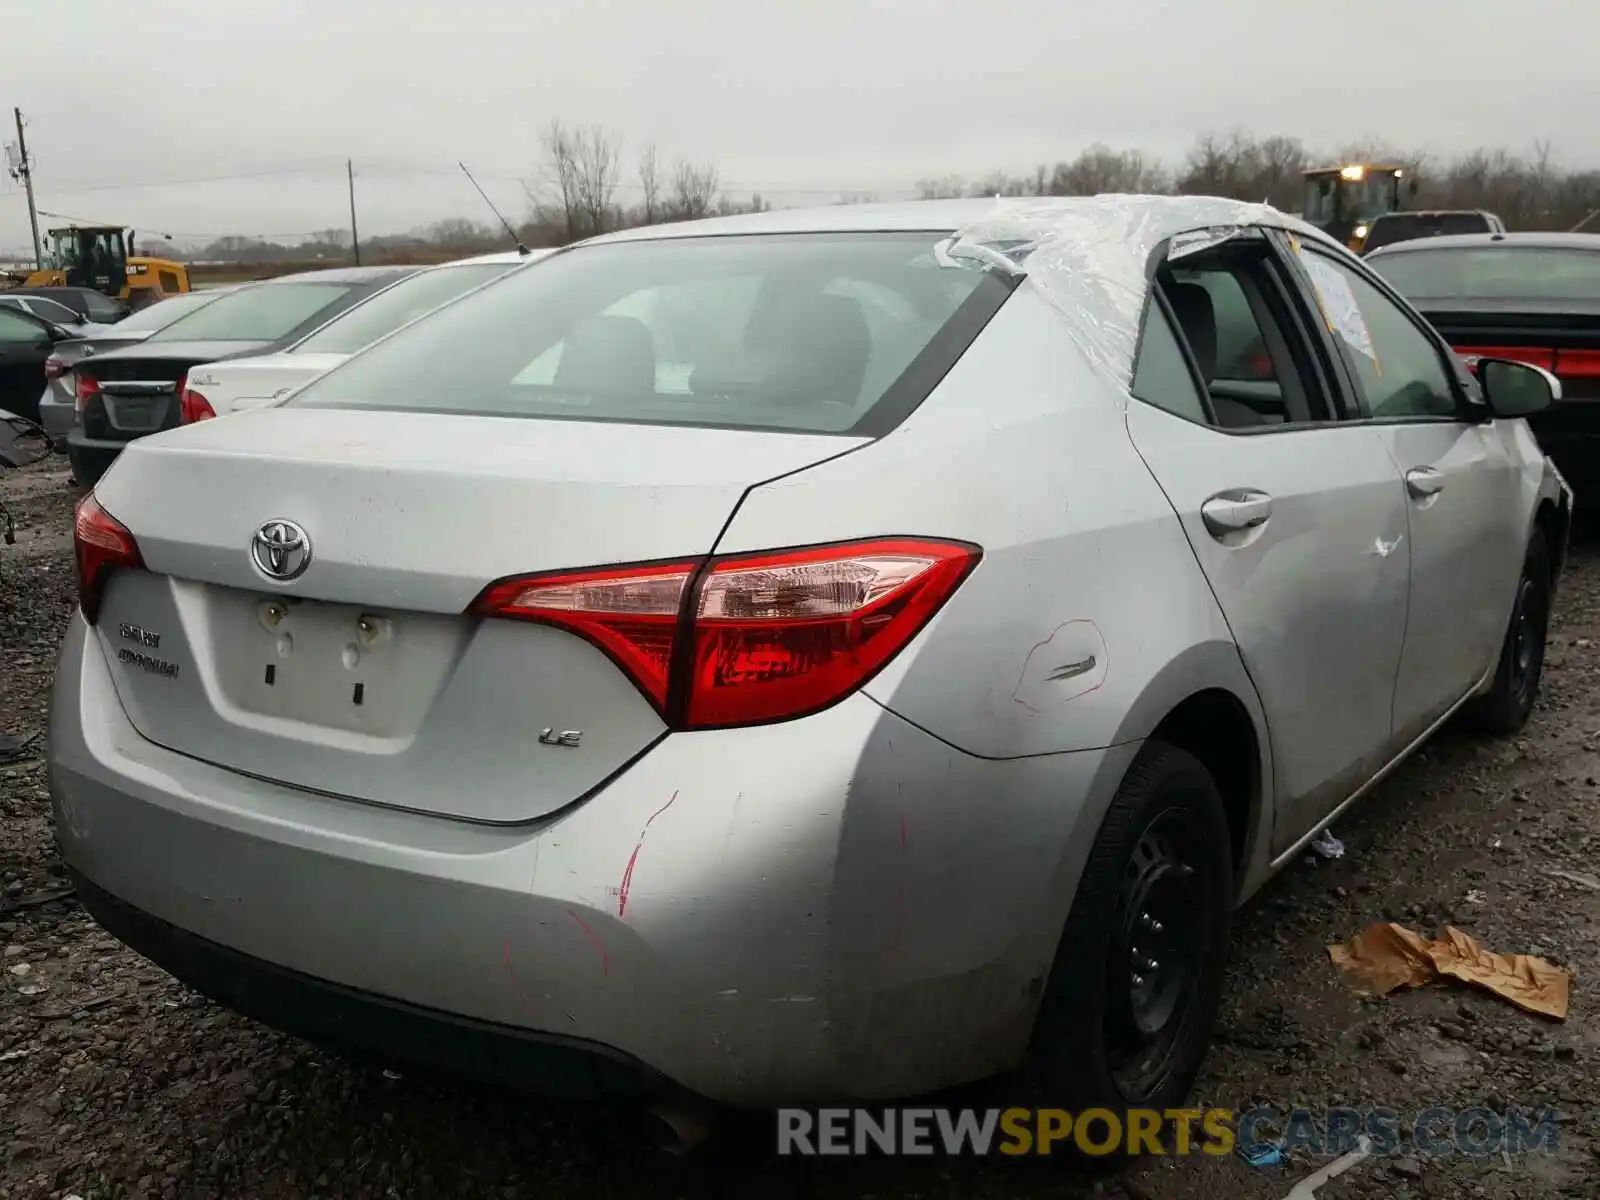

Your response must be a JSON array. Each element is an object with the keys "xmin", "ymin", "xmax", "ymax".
[{"xmin": 50, "ymin": 618, "xmax": 1138, "ymax": 1106}]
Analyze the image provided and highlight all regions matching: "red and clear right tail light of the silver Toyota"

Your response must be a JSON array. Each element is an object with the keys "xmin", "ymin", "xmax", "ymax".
[{"xmin": 469, "ymin": 538, "xmax": 982, "ymax": 730}]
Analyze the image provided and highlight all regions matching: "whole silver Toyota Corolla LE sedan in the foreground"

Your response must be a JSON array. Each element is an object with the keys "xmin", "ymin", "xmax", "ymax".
[{"xmin": 50, "ymin": 197, "xmax": 1571, "ymax": 1109}]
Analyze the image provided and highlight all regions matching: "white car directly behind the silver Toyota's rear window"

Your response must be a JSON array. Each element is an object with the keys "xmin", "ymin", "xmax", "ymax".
[{"xmin": 182, "ymin": 250, "xmax": 554, "ymax": 424}]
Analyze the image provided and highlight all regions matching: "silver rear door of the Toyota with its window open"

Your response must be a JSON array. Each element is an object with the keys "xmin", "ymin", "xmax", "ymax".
[{"xmin": 1128, "ymin": 235, "xmax": 1408, "ymax": 853}]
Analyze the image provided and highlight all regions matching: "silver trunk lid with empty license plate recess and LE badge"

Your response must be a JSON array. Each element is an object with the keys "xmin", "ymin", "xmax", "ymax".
[{"xmin": 96, "ymin": 408, "xmax": 859, "ymax": 822}]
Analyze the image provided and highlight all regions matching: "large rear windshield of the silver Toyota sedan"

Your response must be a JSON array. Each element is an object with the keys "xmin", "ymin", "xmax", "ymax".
[{"xmin": 288, "ymin": 232, "xmax": 1008, "ymax": 434}]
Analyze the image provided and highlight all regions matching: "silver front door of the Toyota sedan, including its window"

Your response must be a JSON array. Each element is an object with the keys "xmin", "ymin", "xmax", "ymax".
[{"xmin": 1273, "ymin": 238, "xmax": 1528, "ymax": 741}]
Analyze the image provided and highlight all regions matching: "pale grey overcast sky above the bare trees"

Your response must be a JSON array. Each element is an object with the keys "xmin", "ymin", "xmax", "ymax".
[{"xmin": 0, "ymin": 0, "xmax": 1600, "ymax": 258}]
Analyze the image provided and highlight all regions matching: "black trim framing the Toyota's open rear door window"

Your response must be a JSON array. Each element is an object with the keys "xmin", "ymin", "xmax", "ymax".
[{"xmin": 1128, "ymin": 233, "xmax": 1341, "ymax": 437}]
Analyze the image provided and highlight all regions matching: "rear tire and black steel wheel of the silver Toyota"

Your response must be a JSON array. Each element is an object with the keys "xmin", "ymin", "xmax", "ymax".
[{"xmin": 1024, "ymin": 741, "xmax": 1234, "ymax": 1118}]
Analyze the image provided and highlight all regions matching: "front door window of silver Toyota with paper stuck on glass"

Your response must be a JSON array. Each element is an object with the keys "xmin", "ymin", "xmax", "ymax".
[{"xmin": 1301, "ymin": 246, "xmax": 1456, "ymax": 419}]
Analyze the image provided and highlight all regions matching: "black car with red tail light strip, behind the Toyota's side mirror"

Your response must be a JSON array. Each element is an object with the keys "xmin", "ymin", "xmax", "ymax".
[{"xmin": 1368, "ymin": 234, "xmax": 1600, "ymax": 496}]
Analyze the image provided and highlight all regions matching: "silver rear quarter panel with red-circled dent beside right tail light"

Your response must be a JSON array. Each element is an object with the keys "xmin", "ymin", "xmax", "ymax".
[{"xmin": 717, "ymin": 285, "xmax": 1243, "ymax": 758}]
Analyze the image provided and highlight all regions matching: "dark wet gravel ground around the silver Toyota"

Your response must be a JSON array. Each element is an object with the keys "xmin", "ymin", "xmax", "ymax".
[{"xmin": 0, "ymin": 459, "xmax": 1600, "ymax": 1200}]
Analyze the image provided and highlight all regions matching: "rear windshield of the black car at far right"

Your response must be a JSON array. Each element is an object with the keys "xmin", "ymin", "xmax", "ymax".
[{"xmin": 1368, "ymin": 243, "xmax": 1600, "ymax": 302}]
